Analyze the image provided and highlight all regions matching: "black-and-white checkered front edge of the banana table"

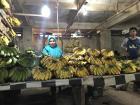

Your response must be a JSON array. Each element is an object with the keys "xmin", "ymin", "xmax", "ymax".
[{"xmin": 0, "ymin": 73, "xmax": 140, "ymax": 91}]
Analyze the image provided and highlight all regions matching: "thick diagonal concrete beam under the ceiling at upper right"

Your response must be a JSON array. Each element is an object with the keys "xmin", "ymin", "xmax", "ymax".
[{"xmin": 96, "ymin": 0, "xmax": 140, "ymax": 29}]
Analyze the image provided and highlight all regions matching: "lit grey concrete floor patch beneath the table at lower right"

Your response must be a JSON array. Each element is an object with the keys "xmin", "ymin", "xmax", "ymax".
[{"xmin": 89, "ymin": 88, "xmax": 140, "ymax": 105}]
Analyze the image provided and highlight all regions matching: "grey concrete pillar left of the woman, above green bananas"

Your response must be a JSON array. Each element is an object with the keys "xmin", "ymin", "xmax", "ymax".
[{"xmin": 19, "ymin": 26, "xmax": 32, "ymax": 52}]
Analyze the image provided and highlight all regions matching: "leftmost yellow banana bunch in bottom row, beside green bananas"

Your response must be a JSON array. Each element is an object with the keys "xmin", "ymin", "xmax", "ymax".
[{"xmin": 32, "ymin": 67, "xmax": 52, "ymax": 81}]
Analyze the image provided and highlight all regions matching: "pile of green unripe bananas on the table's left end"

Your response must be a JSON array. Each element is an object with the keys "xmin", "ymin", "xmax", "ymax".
[{"xmin": 0, "ymin": 45, "xmax": 36, "ymax": 82}]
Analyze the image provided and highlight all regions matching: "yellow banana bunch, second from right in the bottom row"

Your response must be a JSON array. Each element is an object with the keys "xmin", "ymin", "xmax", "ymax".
[{"xmin": 105, "ymin": 63, "xmax": 122, "ymax": 75}]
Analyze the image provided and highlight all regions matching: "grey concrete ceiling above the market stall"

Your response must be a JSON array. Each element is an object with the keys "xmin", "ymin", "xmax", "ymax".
[{"xmin": 10, "ymin": 0, "xmax": 140, "ymax": 33}]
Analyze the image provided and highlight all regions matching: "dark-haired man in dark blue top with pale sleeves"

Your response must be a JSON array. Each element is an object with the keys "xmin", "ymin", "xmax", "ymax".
[{"xmin": 121, "ymin": 27, "xmax": 140, "ymax": 60}]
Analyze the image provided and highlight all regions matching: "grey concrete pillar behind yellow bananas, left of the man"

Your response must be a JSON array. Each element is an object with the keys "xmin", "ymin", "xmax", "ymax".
[{"xmin": 100, "ymin": 29, "xmax": 111, "ymax": 49}]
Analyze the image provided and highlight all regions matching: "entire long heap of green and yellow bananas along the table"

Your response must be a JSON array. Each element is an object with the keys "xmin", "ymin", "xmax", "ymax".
[{"xmin": 0, "ymin": 45, "xmax": 140, "ymax": 82}]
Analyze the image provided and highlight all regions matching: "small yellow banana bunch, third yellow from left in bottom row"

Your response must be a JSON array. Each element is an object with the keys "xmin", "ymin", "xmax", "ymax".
[{"xmin": 74, "ymin": 67, "xmax": 89, "ymax": 78}]
